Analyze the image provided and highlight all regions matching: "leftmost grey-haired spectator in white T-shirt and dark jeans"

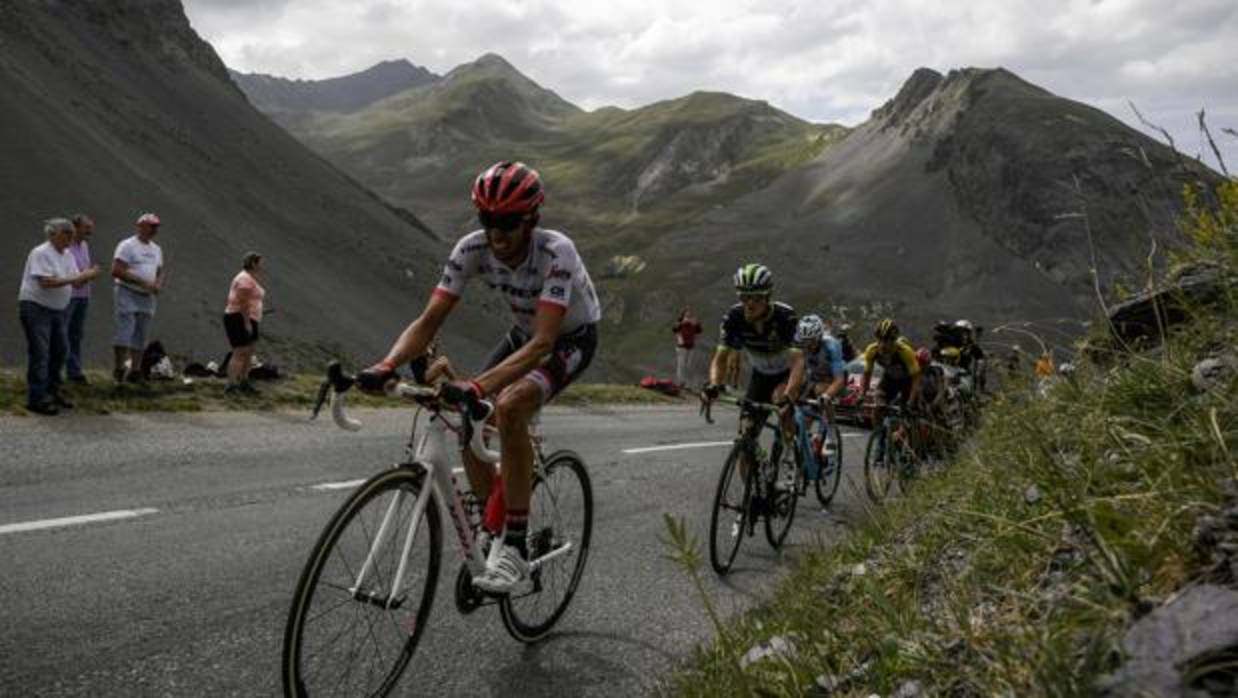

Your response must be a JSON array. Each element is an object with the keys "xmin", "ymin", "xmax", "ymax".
[{"xmin": 17, "ymin": 218, "xmax": 99, "ymax": 415}]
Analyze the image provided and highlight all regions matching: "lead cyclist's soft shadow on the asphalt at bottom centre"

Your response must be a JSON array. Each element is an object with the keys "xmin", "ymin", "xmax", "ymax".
[{"xmin": 489, "ymin": 630, "xmax": 678, "ymax": 697}]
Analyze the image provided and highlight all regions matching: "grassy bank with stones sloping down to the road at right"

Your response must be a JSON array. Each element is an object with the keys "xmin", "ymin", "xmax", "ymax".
[{"xmin": 669, "ymin": 181, "xmax": 1238, "ymax": 697}]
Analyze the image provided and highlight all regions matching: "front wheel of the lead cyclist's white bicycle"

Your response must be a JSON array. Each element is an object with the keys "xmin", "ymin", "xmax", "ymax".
[{"xmin": 282, "ymin": 467, "xmax": 442, "ymax": 698}]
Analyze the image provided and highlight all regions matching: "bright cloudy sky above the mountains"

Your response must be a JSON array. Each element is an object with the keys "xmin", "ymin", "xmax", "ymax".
[{"xmin": 183, "ymin": 0, "xmax": 1238, "ymax": 171}]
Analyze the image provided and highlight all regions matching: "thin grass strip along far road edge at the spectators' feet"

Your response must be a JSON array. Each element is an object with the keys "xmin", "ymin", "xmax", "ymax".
[{"xmin": 0, "ymin": 369, "xmax": 678, "ymax": 415}]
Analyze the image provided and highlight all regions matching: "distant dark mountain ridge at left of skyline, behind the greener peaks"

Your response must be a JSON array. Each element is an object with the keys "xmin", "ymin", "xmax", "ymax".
[{"xmin": 229, "ymin": 59, "xmax": 438, "ymax": 113}]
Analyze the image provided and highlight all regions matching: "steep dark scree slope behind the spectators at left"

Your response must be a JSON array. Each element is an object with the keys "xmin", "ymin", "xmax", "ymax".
[{"xmin": 0, "ymin": 0, "xmax": 502, "ymax": 365}]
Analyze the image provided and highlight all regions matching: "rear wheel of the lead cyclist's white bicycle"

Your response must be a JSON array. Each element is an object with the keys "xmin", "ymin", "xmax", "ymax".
[{"xmin": 499, "ymin": 450, "xmax": 593, "ymax": 642}]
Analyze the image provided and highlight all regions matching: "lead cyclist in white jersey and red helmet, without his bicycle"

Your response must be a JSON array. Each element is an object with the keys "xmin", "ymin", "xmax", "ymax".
[{"xmin": 358, "ymin": 162, "xmax": 602, "ymax": 593}]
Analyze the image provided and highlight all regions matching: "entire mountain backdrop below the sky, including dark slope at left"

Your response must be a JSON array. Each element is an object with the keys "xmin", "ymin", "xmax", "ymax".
[{"xmin": 0, "ymin": 0, "xmax": 1217, "ymax": 379}]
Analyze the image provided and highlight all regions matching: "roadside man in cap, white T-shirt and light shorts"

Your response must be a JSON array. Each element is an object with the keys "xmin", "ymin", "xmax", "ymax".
[{"xmin": 111, "ymin": 213, "xmax": 163, "ymax": 382}]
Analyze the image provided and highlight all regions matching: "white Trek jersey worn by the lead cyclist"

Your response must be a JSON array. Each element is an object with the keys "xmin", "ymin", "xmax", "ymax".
[{"xmin": 435, "ymin": 228, "xmax": 602, "ymax": 337}]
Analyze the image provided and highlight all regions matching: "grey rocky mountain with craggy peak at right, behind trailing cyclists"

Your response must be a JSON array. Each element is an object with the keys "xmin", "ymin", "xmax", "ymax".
[{"xmin": 595, "ymin": 69, "xmax": 1216, "ymax": 371}]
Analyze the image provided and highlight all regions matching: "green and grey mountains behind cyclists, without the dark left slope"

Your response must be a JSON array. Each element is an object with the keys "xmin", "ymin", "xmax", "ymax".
[{"xmin": 233, "ymin": 54, "xmax": 1217, "ymax": 369}]
